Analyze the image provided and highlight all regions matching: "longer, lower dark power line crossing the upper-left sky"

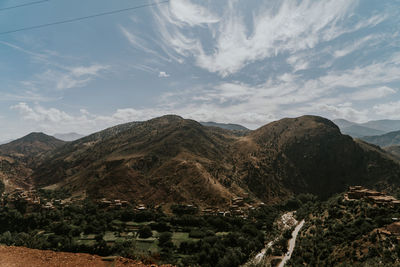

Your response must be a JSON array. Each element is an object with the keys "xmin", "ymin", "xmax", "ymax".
[{"xmin": 0, "ymin": 0, "xmax": 169, "ymax": 35}]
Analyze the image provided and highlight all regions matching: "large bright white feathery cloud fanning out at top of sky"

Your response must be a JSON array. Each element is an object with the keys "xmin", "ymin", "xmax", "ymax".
[{"xmin": 154, "ymin": 0, "xmax": 385, "ymax": 77}]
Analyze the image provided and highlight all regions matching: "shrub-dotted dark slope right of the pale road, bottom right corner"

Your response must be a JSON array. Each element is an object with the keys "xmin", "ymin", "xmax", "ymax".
[{"xmin": 288, "ymin": 191, "xmax": 400, "ymax": 267}]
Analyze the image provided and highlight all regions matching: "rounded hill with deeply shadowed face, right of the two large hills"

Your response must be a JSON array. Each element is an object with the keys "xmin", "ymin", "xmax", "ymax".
[{"xmin": 242, "ymin": 116, "xmax": 400, "ymax": 200}]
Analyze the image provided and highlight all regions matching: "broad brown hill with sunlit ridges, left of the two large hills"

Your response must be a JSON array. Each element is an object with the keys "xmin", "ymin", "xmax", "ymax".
[{"xmin": 33, "ymin": 116, "xmax": 239, "ymax": 207}]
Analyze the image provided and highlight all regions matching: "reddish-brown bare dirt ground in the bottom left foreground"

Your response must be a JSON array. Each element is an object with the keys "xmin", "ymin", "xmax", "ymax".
[{"xmin": 0, "ymin": 246, "xmax": 170, "ymax": 267}]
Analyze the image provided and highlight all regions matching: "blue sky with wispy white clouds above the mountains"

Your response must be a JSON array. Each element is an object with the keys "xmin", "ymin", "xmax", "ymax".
[{"xmin": 0, "ymin": 0, "xmax": 400, "ymax": 141}]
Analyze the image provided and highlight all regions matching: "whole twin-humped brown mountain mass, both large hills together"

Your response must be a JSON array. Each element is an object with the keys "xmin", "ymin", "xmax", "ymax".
[{"xmin": 28, "ymin": 115, "xmax": 400, "ymax": 205}]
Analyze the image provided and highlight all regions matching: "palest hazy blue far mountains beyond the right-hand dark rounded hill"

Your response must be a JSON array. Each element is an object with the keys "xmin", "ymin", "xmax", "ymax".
[{"xmin": 333, "ymin": 119, "xmax": 400, "ymax": 138}]
